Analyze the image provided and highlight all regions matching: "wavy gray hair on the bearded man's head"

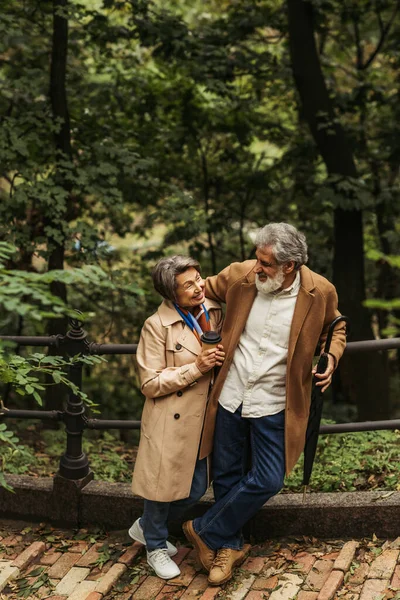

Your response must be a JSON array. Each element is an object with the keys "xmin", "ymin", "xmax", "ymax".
[{"xmin": 255, "ymin": 223, "xmax": 308, "ymax": 271}]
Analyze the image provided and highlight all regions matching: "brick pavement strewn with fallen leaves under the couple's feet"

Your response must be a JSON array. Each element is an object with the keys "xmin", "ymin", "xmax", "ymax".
[{"xmin": 0, "ymin": 520, "xmax": 400, "ymax": 600}]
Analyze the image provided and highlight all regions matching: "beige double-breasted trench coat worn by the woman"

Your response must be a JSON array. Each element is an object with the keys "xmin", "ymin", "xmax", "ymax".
[{"xmin": 132, "ymin": 300, "xmax": 222, "ymax": 502}]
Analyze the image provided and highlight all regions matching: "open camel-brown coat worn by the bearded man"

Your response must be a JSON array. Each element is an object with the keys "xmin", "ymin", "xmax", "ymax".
[{"xmin": 200, "ymin": 260, "xmax": 346, "ymax": 474}]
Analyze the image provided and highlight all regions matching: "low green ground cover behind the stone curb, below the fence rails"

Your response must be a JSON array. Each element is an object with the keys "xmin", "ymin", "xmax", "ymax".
[{"xmin": 0, "ymin": 424, "xmax": 400, "ymax": 493}]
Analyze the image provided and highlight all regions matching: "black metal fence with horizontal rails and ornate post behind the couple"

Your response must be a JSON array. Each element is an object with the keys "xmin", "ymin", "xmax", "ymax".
[{"xmin": 0, "ymin": 320, "xmax": 400, "ymax": 481}]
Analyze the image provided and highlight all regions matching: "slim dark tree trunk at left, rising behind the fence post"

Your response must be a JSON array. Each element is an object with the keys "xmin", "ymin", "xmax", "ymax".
[{"xmin": 46, "ymin": 0, "xmax": 72, "ymax": 410}]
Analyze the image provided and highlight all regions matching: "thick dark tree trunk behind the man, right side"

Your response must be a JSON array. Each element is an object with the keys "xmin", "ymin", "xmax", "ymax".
[{"xmin": 287, "ymin": 0, "xmax": 390, "ymax": 420}]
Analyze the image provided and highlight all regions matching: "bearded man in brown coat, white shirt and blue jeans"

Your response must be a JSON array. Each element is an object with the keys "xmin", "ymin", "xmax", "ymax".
[{"xmin": 183, "ymin": 223, "xmax": 345, "ymax": 585}]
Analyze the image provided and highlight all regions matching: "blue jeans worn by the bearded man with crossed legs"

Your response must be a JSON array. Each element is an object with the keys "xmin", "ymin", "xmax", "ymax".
[{"xmin": 193, "ymin": 406, "xmax": 285, "ymax": 550}]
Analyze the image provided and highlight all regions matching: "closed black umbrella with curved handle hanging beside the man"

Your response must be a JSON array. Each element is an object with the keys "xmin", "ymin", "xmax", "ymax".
[{"xmin": 303, "ymin": 315, "xmax": 350, "ymax": 502}]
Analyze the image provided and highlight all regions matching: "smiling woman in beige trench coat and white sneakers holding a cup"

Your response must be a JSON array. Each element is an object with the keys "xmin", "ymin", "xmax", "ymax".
[{"xmin": 129, "ymin": 256, "xmax": 225, "ymax": 579}]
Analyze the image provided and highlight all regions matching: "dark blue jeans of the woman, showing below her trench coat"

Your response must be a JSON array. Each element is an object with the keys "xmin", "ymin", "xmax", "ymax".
[{"xmin": 140, "ymin": 458, "xmax": 208, "ymax": 552}]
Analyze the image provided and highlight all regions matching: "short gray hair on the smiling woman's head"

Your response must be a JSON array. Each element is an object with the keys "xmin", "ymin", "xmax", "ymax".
[{"xmin": 151, "ymin": 254, "xmax": 201, "ymax": 302}]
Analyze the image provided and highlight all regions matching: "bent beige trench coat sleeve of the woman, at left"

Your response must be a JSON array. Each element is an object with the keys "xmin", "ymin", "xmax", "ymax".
[{"xmin": 136, "ymin": 318, "xmax": 203, "ymax": 398}]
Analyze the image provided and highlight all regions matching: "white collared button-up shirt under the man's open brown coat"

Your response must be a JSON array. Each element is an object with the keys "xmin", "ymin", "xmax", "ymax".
[{"xmin": 219, "ymin": 272, "xmax": 300, "ymax": 417}]
